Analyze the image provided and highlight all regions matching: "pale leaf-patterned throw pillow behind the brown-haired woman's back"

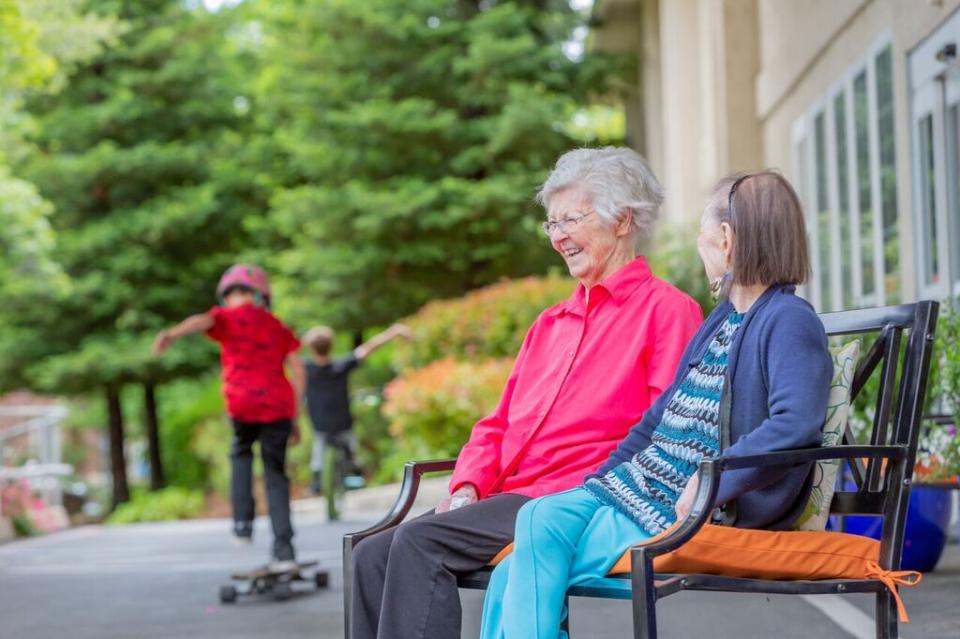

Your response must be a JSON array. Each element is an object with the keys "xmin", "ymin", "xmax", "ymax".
[{"xmin": 793, "ymin": 341, "xmax": 860, "ymax": 530}]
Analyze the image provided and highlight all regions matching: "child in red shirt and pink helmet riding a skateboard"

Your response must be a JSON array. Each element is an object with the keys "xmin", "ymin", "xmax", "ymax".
[{"xmin": 153, "ymin": 264, "xmax": 304, "ymax": 568}]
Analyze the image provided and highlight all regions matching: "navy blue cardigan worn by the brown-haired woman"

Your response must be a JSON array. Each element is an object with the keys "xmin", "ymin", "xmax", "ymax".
[{"xmin": 597, "ymin": 285, "xmax": 833, "ymax": 530}]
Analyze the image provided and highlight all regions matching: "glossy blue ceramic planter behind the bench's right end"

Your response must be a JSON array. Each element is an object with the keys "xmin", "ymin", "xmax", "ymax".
[{"xmin": 843, "ymin": 486, "xmax": 952, "ymax": 572}]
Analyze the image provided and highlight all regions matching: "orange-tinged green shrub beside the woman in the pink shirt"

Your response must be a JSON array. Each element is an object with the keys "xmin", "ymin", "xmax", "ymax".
[{"xmin": 351, "ymin": 273, "xmax": 576, "ymax": 484}]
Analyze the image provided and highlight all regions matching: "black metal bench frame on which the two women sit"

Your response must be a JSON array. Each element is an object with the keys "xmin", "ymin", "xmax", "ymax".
[{"xmin": 343, "ymin": 301, "xmax": 939, "ymax": 639}]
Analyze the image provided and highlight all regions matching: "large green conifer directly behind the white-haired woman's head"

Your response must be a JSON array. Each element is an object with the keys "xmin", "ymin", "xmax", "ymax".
[{"xmin": 250, "ymin": 0, "xmax": 622, "ymax": 332}]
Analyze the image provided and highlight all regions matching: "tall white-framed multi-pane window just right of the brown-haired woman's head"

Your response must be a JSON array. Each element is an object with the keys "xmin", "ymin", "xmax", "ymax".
[{"xmin": 793, "ymin": 38, "xmax": 900, "ymax": 311}]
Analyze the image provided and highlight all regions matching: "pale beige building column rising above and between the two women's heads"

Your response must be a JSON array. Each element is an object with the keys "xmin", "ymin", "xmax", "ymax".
[{"xmin": 659, "ymin": 0, "xmax": 763, "ymax": 227}]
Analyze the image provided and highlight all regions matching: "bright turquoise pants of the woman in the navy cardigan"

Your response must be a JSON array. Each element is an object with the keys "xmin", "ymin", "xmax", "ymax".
[{"xmin": 480, "ymin": 488, "xmax": 650, "ymax": 639}]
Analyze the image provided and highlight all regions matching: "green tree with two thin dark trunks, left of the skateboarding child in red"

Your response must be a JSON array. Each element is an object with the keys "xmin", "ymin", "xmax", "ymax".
[{"xmin": 8, "ymin": 0, "xmax": 267, "ymax": 504}]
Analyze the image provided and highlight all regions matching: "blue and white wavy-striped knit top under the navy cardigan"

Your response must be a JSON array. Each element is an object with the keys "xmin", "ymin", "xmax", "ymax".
[{"xmin": 584, "ymin": 312, "xmax": 743, "ymax": 535}]
